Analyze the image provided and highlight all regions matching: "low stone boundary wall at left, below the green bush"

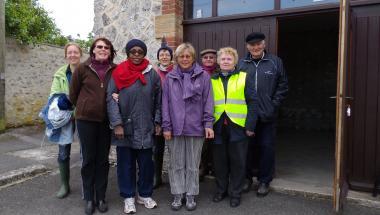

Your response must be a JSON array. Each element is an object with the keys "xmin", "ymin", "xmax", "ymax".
[{"xmin": 5, "ymin": 38, "xmax": 87, "ymax": 127}]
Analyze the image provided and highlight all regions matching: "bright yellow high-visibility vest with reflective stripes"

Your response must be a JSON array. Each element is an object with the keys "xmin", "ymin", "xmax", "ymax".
[{"xmin": 211, "ymin": 72, "xmax": 247, "ymax": 127}]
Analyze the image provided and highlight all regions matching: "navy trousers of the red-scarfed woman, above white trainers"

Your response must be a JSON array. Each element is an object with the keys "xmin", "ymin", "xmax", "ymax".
[{"xmin": 116, "ymin": 146, "xmax": 154, "ymax": 198}]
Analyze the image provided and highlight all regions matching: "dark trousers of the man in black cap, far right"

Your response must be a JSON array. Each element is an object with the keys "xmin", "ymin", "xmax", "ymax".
[{"xmin": 247, "ymin": 120, "xmax": 276, "ymax": 184}]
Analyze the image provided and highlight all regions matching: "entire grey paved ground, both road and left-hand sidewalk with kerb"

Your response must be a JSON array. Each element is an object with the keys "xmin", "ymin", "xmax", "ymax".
[{"xmin": 0, "ymin": 127, "xmax": 380, "ymax": 215}]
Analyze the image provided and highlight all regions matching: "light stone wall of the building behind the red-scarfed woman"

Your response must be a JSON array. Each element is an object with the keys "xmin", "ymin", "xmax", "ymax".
[{"xmin": 93, "ymin": 0, "xmax": 162, "ymax": 62}]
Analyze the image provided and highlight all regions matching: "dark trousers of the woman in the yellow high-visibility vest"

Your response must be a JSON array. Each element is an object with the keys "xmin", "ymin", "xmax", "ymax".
[{"xmin": 212, "ymin": 126, "xmax": 248, "ymax": 198}]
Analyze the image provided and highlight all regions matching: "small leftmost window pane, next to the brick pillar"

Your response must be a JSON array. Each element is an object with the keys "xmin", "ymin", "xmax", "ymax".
[{"xmin": 187, "ymin": 0, "xmax": 212, "ymax": 19}]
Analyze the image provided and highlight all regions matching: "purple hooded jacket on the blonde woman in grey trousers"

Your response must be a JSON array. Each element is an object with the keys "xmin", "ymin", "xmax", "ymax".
[{"xmin": 162, "ymin": 63, "xmax": 214, "ymax": 137}]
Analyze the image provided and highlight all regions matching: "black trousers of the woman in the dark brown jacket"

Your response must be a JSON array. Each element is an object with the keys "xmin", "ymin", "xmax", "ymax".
[{"xmin": 77, "ymin": 120, "xmax": 111, "ymax": 201}]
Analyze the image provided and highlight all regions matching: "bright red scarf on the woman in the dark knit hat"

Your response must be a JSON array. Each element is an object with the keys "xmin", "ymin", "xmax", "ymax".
[{"xmin": 112, "ymin": 58, "xmax": 149, "ymax": 90}]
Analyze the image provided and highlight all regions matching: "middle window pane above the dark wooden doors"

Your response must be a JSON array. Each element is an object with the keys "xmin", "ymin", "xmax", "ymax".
[{"xmin": 217, "ymin": 0, "xmax": 274, "ymax": 16}]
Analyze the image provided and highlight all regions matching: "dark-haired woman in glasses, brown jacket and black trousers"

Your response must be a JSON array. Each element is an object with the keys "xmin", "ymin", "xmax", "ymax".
[{"xmin": 70, "ymin": 37, "xmax": 116, "ymax": 214}]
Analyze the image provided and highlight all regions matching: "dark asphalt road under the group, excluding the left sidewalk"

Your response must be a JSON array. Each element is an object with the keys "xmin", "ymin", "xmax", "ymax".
[{"xmin": 0, "ymin": 167, "xmax": 380, "ymax": 215}]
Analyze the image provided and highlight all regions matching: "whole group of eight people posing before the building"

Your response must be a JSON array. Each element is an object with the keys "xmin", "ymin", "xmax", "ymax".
[{"xmin": 51, "ymin": 32, "xmax": 288, "ymax": 214}]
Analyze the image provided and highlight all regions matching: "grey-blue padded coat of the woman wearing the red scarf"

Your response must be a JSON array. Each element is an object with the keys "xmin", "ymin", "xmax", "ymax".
[{"xmin": 107, "ymin": 65, "xmax": 161, "ymax": 149}]
